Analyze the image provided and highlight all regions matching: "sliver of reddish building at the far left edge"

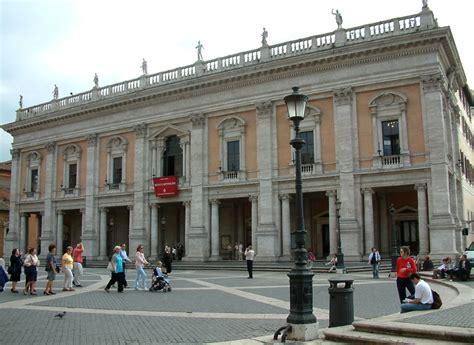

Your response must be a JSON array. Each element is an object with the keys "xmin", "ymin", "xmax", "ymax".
[{"xmin": 0, "ymin": 161, "xmax": 11, "ymax": 257}]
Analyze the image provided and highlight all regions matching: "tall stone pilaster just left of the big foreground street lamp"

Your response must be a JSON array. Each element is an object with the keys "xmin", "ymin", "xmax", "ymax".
[{"xmin": 256, "ymin": 102, "xmax": 279, "ymax": 260}]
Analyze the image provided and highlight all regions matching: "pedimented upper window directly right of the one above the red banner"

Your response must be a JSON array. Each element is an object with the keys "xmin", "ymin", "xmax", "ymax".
[{"xmin": 217, "ymin": 116, "xmax": 246, "ymax": 181}]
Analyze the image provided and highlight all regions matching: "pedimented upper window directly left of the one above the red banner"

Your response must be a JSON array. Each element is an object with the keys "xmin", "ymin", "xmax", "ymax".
[{"xmin": 105, "ymin": 136, "xmax": 128, "ymax": 192}]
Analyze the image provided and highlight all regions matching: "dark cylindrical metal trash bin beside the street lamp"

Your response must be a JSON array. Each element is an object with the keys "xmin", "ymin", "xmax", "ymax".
[{"xmin": 328, "ymin": 276, "xmax": 354, "ymax": 327}]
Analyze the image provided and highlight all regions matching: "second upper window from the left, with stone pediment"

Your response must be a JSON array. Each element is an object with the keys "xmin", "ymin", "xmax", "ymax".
[{"xmin": 61, "ymin": 144, "xmax": 81, "ymax": 196}]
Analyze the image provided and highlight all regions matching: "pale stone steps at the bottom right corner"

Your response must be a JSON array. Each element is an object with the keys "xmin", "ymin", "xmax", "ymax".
[{"xmin": 323, "ymin": 325, "xmax": 472, "ymax": 344}]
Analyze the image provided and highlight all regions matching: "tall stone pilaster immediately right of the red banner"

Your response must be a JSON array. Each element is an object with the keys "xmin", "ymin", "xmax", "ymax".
[{"xmin": 186, "ymin": 113, "xmax": 209, "ymax": 260}]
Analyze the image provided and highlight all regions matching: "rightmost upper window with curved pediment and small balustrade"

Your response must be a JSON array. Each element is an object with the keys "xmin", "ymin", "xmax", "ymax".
[{"xmin": 369, "ymin": 91, "xmax": 410, "ymax": 168}]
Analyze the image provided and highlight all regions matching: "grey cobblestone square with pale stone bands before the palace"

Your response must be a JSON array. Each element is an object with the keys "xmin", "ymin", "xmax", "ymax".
[{"xmin": 0, "ymin": 269, "xmax": 466, "ymax": 345}]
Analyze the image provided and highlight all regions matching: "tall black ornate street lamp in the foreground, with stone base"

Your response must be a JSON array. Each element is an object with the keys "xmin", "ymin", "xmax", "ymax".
[{"xmin": 274, "ymin": 87, "xmax": 318, "ymax": 341}]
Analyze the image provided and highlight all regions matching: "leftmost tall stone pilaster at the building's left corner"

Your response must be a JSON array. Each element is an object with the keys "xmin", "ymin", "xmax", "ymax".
[{"xmin": 5, "ymin": 149, "xmax": 22, "ymax": 255}]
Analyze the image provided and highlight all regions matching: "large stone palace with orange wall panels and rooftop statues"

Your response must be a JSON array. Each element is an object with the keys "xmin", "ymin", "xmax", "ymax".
[{"xmin": 3, "ymin": 7, "xmax": 474, "ymax": 260}]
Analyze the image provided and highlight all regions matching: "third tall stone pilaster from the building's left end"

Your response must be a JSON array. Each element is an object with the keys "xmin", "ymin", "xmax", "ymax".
[{"xmin": 81, "ymin": 134, "xmax": 100, "ymax": 257}]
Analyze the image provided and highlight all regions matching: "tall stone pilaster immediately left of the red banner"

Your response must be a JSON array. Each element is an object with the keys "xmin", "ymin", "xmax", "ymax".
[{"xmin": 128, "ymin": 123, "xmax": 148, "ymax": 253}]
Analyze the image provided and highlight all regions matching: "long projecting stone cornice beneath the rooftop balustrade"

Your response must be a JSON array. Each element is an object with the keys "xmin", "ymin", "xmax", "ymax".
[{"xmin": 2, "ymin": 34, "xmax": 447, "ymax": 133}]
